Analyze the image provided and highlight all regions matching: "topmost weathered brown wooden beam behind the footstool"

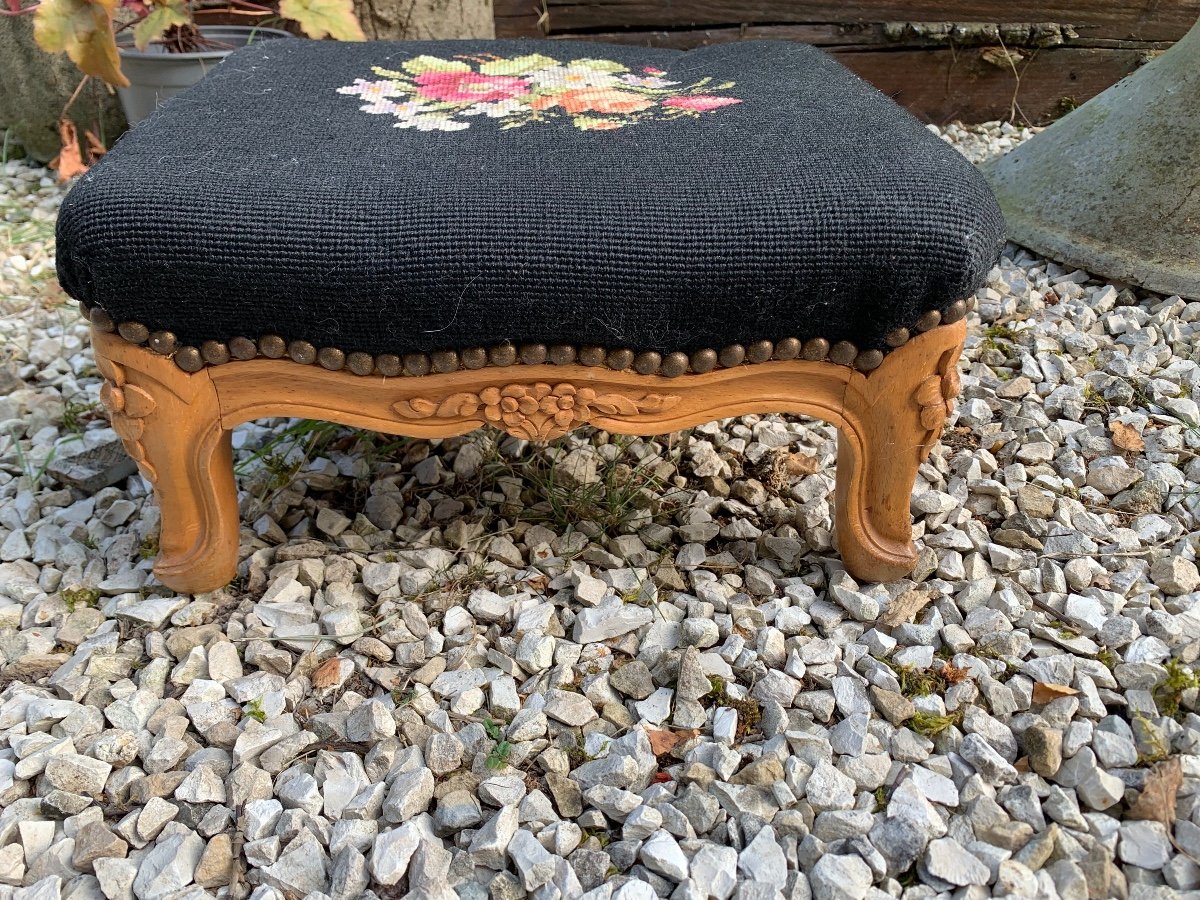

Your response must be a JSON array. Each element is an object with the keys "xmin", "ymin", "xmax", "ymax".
[{"xmin": 496, "ymin": 0, "xmax": 1200, "ymax": 41}]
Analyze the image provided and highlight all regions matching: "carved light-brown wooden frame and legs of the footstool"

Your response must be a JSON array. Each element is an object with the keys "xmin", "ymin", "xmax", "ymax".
[{"xmin": 92, "ymin": 322, "xmax": 966, "ymax": 593}]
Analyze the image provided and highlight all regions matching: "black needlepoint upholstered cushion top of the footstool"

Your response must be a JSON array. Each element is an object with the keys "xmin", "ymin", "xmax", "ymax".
[{"xmin": 58, "ymin": 40, "xmax": 1003, "ymax": 353}]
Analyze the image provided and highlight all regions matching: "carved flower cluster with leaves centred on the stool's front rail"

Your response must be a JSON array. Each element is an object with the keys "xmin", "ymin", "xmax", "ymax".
[{"xmin": 392, "ymin": 382, "xmax": 679, "ymax": 440}]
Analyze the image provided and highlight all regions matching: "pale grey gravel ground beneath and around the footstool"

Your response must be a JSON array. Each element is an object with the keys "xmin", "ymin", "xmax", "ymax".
[{"xmin": 0, "ymin": 125, "xmax": 1200, "ymax": 900}]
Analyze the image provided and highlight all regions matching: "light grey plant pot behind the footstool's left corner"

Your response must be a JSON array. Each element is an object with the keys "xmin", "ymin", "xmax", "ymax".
[{"xmin": 116, "ymin": 25, "xmax": 292, "ymax": 125}]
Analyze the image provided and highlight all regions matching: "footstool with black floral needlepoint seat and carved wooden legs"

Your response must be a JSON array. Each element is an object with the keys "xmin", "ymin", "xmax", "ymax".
[{"xmin": 58, "ymin": 41, "xmax": 1003, "ymax": 592}]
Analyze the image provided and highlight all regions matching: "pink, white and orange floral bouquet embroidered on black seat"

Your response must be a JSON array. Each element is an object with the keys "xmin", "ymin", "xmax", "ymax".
[{"xmin": 337, "ymin": 54, "xmax": 742, "ymax": 131}]
